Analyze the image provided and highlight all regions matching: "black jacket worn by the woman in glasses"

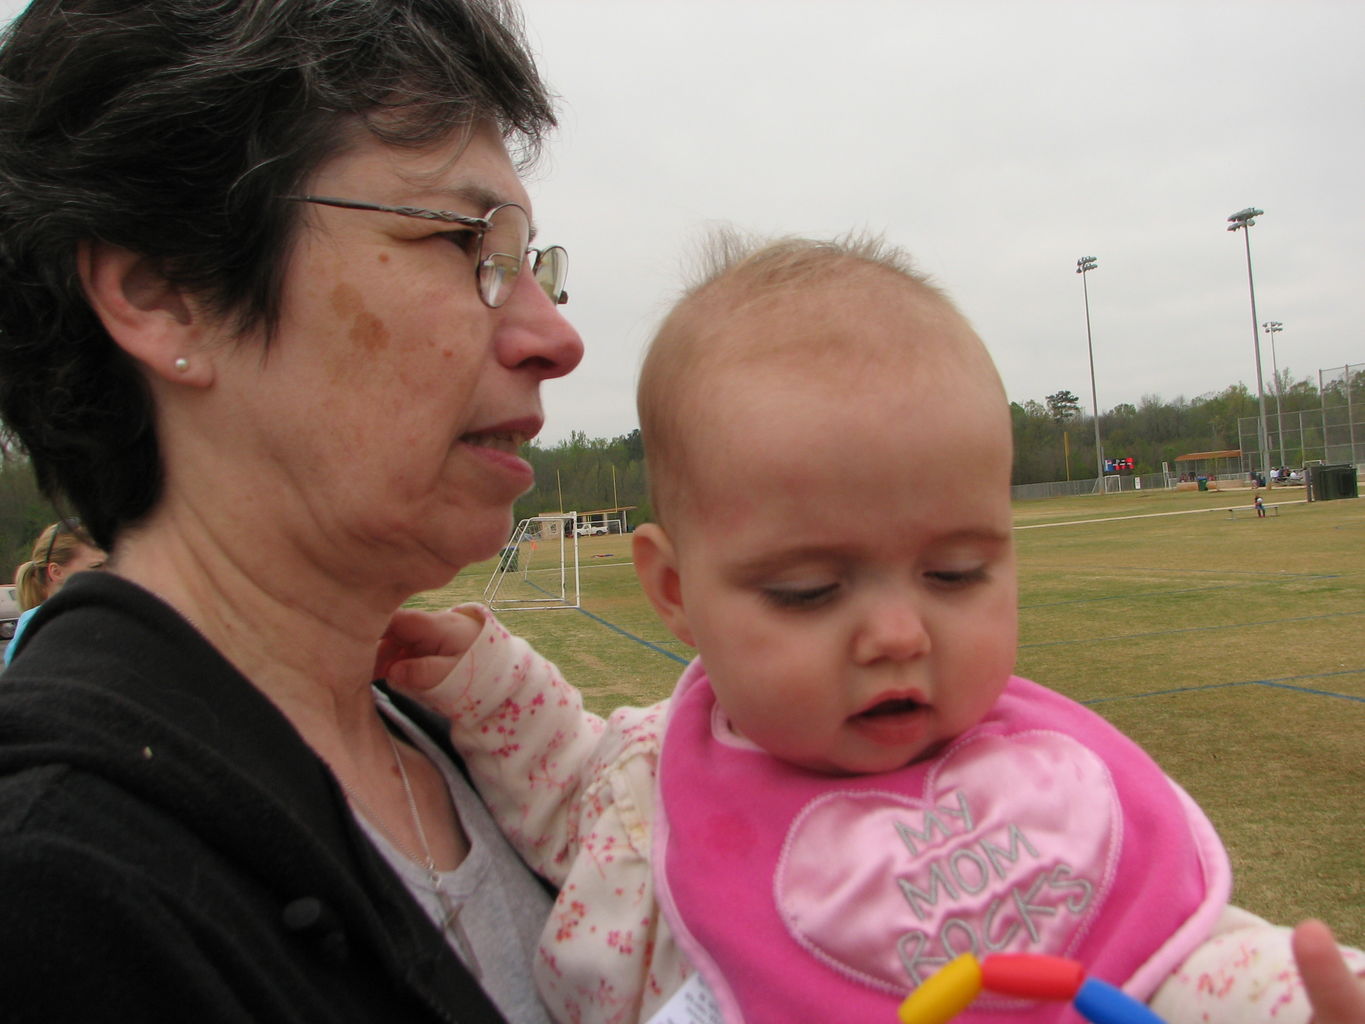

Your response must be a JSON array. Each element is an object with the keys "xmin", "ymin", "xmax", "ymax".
[{"xmin": 0, "ymin": 573, "xmax": 501, "ymax": 1024}]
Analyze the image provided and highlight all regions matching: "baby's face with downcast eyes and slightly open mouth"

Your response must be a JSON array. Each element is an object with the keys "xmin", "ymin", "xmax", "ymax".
[{"xmin": 655, "ymin": 292, "xmax": 1017, "ymax": 773}]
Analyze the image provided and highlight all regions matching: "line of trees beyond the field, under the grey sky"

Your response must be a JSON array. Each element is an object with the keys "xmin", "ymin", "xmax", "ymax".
[{"xmin": 0, "ymin": 370, "xmax": 1365, "ymax": 565}]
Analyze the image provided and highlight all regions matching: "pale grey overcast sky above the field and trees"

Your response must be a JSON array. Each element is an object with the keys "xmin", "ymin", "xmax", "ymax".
[{"xmin": 0, "ymin": 0, "xmax": 1365, "ymax": 444}]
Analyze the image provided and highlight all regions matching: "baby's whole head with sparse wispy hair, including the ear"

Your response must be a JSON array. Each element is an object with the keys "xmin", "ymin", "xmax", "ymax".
[{"xmin": 635, "ymin": 236, "xmax": 1016, "ymax": 773}]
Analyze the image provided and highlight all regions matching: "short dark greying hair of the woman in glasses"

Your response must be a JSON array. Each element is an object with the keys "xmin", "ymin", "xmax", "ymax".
[{"xmin": 0, "ymin": 0, "xmax": 554, "ymax": 547}]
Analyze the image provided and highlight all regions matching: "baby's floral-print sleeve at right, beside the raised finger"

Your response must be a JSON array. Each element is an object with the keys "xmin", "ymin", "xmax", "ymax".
[{"xmin": 1148, "ymin": 907, "xmax": 1365, "ymax": 1024}]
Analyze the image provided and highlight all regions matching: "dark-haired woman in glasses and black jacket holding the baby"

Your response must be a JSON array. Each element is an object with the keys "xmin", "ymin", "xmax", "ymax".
[{"xmin": 0, "ymin": 0, "xmax": 583, "ymax": 1021}]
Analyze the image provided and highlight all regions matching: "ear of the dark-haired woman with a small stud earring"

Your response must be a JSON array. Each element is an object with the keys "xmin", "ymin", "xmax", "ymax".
[{"xmin": 76, "ymin": 240, "xmax": 213, "ymax": 386}]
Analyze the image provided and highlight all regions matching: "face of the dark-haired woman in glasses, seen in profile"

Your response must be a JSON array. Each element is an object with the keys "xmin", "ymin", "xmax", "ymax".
[{"xmin": 209, "ymin": 122, "xmax": 583, "ymax": 593}]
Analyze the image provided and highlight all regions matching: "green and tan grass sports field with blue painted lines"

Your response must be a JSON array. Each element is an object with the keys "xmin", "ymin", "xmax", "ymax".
[{"xmin": 410, "ymin": 487, "xmax": 1365, "ymax": 946}]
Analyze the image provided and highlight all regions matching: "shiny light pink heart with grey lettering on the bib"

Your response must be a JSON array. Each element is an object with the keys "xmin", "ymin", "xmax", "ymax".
[{"xmin": 773, "ymin": 730, "xmax": 1123, "ymax": 993}]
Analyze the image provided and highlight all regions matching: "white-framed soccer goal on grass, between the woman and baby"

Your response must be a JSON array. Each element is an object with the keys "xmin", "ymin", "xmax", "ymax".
[{"xmin": 483, "ymin": 512, "xmax": 579, "ymax": 612}]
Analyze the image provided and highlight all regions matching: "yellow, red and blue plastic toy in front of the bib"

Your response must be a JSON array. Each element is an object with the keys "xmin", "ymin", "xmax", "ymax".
[{"xmin": 897, "ymin": 953, "xmax": 1163, "ymax": 1024}]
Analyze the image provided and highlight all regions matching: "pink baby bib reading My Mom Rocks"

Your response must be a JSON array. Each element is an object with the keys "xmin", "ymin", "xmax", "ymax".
[{"xmin": 655, "ymin": 661, "xmax": 1231, "ymax": 1024}]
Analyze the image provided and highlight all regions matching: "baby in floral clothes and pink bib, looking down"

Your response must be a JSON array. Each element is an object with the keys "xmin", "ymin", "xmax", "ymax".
[{"xmin": 379, "ymin": 239, "xmax": 1365, "ymax": 1024}]
